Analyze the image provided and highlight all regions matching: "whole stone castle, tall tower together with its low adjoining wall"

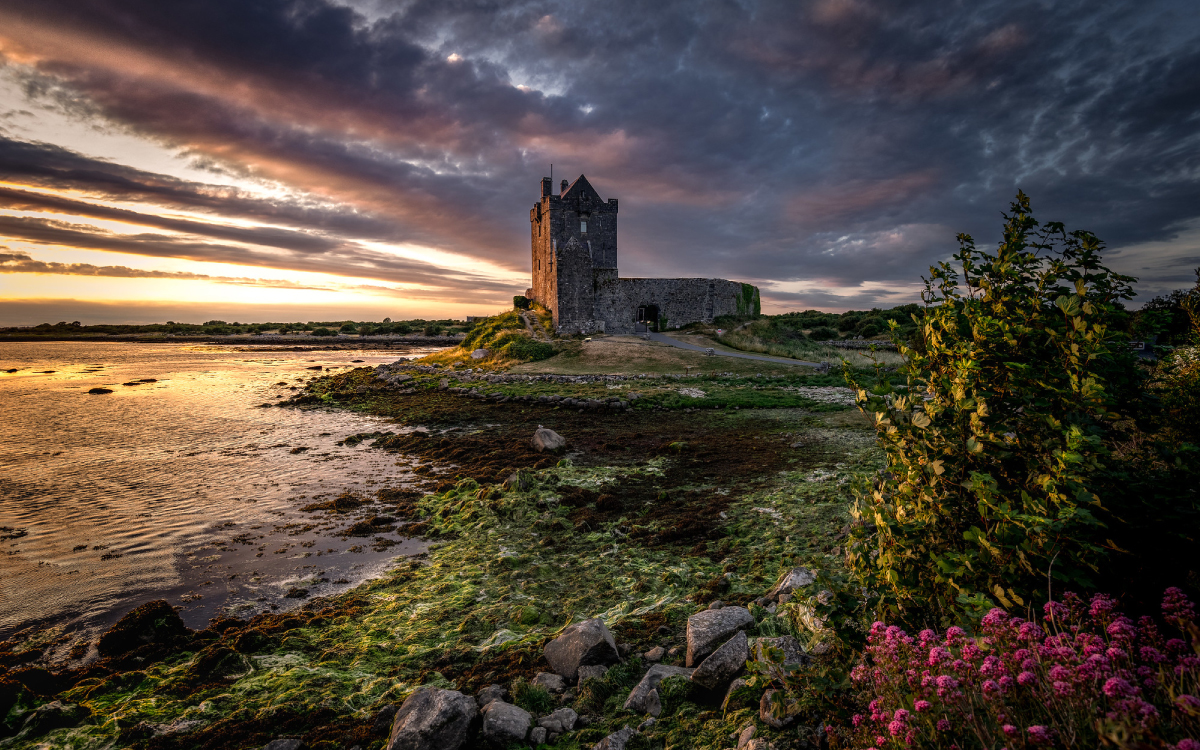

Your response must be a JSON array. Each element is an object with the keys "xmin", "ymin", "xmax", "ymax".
[{"xmin": 526, "ymin": 175, "xmax": 758, "ymax": 334}]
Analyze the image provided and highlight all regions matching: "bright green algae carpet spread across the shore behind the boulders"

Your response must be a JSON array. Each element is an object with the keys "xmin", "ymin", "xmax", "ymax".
[{"xmin": 0, "ymin": 376, "xmax": 881, "ymax": 750}]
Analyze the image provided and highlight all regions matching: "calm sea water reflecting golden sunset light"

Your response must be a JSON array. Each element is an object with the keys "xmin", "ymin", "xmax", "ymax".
[{"xmin": 0, "ymin": 342, "xmax": 424, "ymax": 638}]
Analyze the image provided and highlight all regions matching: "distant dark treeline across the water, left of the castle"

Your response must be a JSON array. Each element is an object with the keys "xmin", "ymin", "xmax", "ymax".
[{"xmin": 0, "ymin": 318, "xmax": 473, "ymax": 338}]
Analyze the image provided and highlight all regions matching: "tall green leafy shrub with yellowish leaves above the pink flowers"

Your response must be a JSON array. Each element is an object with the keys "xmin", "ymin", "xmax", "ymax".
[{"xmin": 846, "ymin": 193, "xmax": 1133, "ymax": 620}]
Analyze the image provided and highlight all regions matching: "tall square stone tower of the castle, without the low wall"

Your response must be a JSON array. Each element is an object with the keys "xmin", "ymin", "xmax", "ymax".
[{"xmin": 529, "ymin": 174, "xmax": 617, "ymax": 329}]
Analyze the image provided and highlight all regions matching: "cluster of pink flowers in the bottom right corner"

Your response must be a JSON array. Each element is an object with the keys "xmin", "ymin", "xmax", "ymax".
[{"xmin": 844, "ymin": 588, "xmax": 1200, "ymax": 750}]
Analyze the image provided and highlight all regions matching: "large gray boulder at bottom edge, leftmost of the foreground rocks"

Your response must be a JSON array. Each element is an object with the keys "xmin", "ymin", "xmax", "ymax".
[{"xmin": 388, "ymin": 688, "xmax": 479, "ymax": 750}]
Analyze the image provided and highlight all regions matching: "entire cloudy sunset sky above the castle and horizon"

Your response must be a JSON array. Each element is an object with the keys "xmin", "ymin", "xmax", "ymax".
[{"xmin": 0, "ymin": 0, "xmax": 1200, "ymax": 325}]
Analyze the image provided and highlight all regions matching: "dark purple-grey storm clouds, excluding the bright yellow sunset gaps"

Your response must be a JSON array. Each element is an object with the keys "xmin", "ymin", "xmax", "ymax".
[{"xmin": 0, "ymin": 0, "xmax": 1200, "ymax": 305}]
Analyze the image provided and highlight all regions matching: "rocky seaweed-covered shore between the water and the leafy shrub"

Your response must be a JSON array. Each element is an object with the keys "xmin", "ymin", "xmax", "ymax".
[{"xmin": 0, "ymin": 362, "xmax": 874, "ymax": 750}]
